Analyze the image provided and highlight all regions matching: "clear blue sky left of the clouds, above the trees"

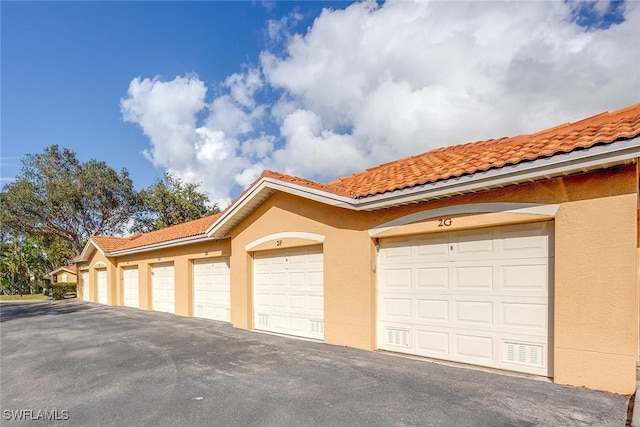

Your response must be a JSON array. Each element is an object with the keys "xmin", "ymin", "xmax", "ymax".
[{"xmin": 1, "ymin": 2, "xmax": 341, "ymax": 192}]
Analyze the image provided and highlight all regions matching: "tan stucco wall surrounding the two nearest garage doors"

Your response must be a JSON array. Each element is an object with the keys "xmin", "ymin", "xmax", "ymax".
[{"xmin": 230, "ymin": 166, "xmax": 638, "ymax": 394}]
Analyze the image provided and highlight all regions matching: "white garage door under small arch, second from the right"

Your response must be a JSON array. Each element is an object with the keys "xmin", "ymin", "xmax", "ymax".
[{"xmin": 253, "ymin": 247, "xmax": 324, "ymax": 339}]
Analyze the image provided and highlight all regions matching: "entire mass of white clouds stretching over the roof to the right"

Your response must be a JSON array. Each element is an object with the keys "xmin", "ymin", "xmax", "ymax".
[{"xmin": 122, "ymin": 1, "xmax": 640, "ymax": 206}]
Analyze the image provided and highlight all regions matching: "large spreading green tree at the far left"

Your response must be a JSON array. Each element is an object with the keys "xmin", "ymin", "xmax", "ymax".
[{"xmin": 0, "ymin": 145, "xmax": 138, "ymax": 253}]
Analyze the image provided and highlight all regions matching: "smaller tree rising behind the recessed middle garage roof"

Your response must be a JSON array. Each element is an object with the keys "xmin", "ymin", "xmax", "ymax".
[{"xmin": 133, "ymin": 172, "xmax": 220, "ymax": 233}]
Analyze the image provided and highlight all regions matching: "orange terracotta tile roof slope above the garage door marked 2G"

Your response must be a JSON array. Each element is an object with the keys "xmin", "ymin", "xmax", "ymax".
[{"xmin": 325, "ymin": 104, "xmax": 640, "ymax": 198}]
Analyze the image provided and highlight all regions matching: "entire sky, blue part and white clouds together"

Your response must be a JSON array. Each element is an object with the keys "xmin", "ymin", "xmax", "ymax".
[{"xmin": 0, "ymin": 1, "xmax": 640, "ymax": 205}]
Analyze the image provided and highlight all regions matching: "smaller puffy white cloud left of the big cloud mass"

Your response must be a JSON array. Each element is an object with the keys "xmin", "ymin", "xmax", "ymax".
[{"xmin": 120, "ymin": 76, "xmax": 256, "ymax": 206}]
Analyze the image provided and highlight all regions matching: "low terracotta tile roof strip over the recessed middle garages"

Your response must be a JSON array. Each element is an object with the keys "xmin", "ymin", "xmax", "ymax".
[{"xmin": 91, "ymin": 214, "xmax": 220, "ymax": 253}]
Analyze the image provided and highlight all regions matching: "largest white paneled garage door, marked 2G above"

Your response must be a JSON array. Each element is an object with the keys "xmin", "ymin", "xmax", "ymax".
[{"xmin": 378, "ymin": 223, "xmax": 553, "ymax": 376}]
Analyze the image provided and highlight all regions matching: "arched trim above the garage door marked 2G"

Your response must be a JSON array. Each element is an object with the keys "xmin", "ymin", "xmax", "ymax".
[{"xmin": 369, "ymin": 203, "xmax": 558, "ymax": 237}]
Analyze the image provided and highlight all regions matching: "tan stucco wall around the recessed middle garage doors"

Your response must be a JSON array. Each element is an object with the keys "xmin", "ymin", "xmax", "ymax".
[{"xmin": 116, "ymin": 239, "xmax": 231, "ymax": 316}]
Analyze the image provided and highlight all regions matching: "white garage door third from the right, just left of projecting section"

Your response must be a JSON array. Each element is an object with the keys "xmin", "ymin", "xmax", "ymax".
[{"xmin": 193, "ymin": 259, "xmax": 231, "ymax": 322}]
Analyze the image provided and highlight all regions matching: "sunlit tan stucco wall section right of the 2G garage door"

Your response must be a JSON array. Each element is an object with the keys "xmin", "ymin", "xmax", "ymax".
[{"xmin": 554, "ymin": 193, "xmax": 638, "ymax": 394}]
